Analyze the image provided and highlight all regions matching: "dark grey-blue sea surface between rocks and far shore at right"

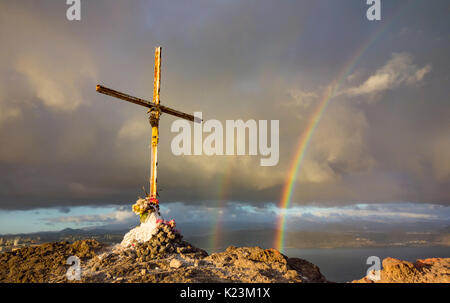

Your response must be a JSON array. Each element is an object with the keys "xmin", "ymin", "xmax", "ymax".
[{"xmin": 283, "ymin": 247, "xmax": 450, "ymax": 282}]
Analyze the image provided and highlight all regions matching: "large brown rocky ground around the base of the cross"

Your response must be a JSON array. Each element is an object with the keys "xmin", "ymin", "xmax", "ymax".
[{"xmin": 0, "ymin": 226, "xmax": 327, "ymax": 283}]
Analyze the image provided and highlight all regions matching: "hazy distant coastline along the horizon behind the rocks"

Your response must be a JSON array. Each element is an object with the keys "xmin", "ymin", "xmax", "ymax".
[{"xmin": 0, "ymin": 228, "xmax": 450, "ymax": 253}]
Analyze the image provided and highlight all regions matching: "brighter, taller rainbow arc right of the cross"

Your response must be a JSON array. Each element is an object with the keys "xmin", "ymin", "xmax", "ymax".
[{"xmin": 273, "ymin": 9, "xmax": 400, "ymax": 252}]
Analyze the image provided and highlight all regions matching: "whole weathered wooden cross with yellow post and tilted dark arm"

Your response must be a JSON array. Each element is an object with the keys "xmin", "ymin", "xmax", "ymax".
[{"xmin": 96, "ymin": 47, "xmax": 202, "ymax": 198}]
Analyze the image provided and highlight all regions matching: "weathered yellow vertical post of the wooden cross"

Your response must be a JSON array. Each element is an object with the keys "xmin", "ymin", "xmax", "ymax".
[{"xmin": 150, "ymin": 46, "xmax": 161, "ymax": 198}]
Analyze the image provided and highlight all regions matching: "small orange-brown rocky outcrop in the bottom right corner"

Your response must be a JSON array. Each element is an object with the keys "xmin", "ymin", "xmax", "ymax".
[{"xmin": 353, "ymin": 258, "xmax": 450, "ymax": 283}]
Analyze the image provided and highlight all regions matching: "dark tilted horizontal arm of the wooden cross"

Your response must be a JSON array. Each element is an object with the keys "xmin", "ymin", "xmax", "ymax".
[{"xmin": 96, "ymin": 85, "xmax": 202, "ymax": 123}]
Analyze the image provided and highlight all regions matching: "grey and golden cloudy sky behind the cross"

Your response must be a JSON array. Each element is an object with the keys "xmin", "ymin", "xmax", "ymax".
[{"xmin": 0, "ymin": 0, "xmax": 450, "ymax": 233}]
